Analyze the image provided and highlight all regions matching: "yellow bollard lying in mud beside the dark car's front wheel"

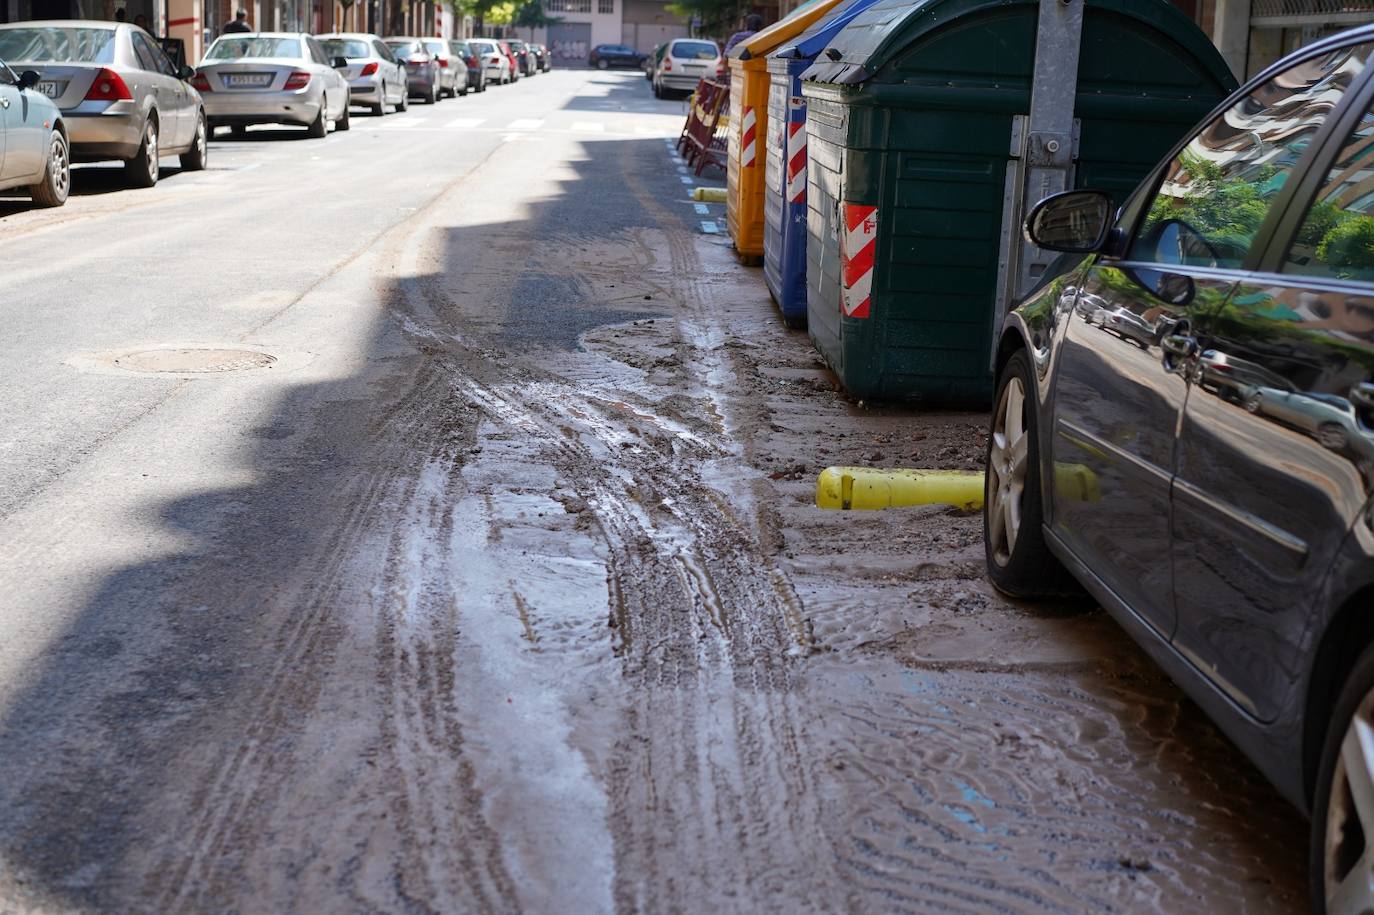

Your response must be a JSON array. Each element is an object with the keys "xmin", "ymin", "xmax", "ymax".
[{"xmin": 816, "ymin": 467, "xmax": 982, "ymax": 511}]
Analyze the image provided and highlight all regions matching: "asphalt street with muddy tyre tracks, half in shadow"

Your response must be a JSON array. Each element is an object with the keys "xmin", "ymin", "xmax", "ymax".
[{"xmin": 0, "ymin": 69, "xmax": 1308, "ymax": 912}]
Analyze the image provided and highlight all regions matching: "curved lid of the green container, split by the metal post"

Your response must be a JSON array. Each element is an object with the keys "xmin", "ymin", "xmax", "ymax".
[{"xmin": 801, "ymin": 0, "xmax": 1234, "ymax": 85}]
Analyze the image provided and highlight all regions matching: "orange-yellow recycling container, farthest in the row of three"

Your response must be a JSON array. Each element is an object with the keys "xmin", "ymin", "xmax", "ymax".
[{"xmin": 725, "ymin": 0, "xmax": 841, "ymax": 264}]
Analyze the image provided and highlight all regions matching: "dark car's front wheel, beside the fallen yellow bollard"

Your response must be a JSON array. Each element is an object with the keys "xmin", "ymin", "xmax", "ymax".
[{"xmin": 982, "ymin": 349, "xmax": 1076, "ymax": 598}]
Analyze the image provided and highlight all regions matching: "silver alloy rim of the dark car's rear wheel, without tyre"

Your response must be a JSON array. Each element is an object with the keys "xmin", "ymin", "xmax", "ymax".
[{"xmin": 1322, "ymin": 691, "xmax": 1374, "ymax": 915}]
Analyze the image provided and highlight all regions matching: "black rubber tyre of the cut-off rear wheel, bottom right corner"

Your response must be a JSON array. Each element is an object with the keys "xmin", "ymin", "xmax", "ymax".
[{"xmin": 1308, "ymin": 637, "xmax": 1374, "ymax": 914}]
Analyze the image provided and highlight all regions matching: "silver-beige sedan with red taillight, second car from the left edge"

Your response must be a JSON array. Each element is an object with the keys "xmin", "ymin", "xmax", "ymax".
[{"xmin": 0, "ymin": 19, "xmax": 209, "ymax": 187}]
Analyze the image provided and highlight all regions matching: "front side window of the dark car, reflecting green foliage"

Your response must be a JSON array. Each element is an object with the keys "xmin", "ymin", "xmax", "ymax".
[{"xmin": 1131, "ymin": 44, "xmax": 1374, "ymax": 268}]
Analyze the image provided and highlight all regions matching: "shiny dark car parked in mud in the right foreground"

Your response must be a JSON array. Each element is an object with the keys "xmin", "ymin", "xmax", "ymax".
[{"xmin": 984, "ymin": 27, "xmax": 1374, "ymax": 912}]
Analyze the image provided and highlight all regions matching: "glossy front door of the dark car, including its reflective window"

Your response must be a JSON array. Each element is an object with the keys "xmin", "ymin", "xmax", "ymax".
[{"xmin": 1051, "ymin": 42, "xmax": 1363, "ymax": 636}]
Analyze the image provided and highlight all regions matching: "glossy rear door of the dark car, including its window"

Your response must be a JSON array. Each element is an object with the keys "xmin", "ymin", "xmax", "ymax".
[{"xmin": 1173, "ymin": 58, "xmax": 1374, "ymax": 721}]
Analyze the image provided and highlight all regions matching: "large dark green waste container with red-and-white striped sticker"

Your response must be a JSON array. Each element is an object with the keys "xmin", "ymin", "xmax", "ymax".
[{"xmin": 801, "ymin": 0, "xmax": 1235, "ymax": 405}]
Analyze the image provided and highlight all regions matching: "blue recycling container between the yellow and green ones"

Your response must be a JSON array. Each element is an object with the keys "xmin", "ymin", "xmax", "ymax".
[{"xmin": 764, "ymin": 0, "xmax": 877, "ymax": 327}]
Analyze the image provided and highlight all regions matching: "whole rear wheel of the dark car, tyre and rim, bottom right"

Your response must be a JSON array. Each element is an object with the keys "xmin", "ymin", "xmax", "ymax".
[{"xmin": 1308, "ymin": 647, "xmax": 1374, "ymax": 915}]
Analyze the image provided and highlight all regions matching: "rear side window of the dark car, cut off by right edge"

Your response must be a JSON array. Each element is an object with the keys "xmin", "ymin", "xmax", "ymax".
[{"xmin": 1282, "ymin": 95, "xmax": 1374, "ymax": 282}]
